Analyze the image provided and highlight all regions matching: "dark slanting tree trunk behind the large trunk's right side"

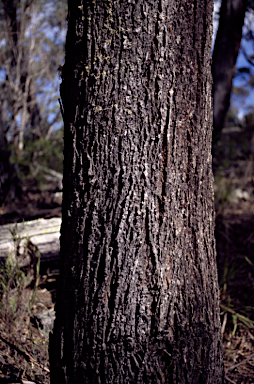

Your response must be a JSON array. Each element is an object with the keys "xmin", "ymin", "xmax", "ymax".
[{"xmin": 212, "ymin": 0, "xmax": 247, "ymax": 145}]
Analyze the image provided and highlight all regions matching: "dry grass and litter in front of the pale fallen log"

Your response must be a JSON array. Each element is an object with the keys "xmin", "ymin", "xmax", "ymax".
[{"xmin": 0, "ymin": 233, "xmax": 53, "ymax": 384}]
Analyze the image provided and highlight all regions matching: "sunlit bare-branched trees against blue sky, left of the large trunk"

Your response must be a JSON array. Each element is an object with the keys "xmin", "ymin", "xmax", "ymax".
[{"xmin": 0, "ymin": 0, "xmax": 66, "ymax": 204}]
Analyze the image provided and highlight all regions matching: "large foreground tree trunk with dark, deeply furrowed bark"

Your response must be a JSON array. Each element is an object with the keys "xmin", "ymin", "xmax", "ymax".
[{"xmin": 50, "ymin": 0, "xmax": 223, "ymax": 384}]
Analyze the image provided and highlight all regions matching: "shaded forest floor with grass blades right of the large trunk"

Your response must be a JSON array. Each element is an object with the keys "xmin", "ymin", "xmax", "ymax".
[{"xmin": 216, "ymin": 201, "xmax": 254, "ymax": 384}]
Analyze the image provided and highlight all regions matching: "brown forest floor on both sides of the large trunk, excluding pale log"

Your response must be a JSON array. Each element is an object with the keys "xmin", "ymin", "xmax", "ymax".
[{"xmin": 0, "ymin": 188, "xmax": 254, "ymax": 384}]
